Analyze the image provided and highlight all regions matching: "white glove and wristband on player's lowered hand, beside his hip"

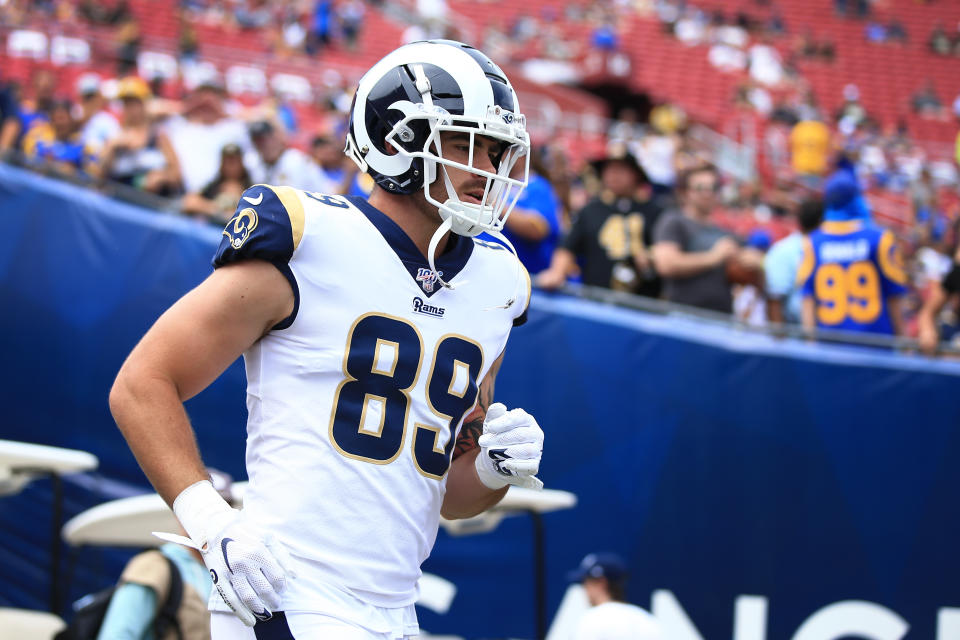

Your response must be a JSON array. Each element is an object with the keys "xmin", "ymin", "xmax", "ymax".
[{"xmin": 168, "ymin": 480, "xmax": 293, "ymax": 627}]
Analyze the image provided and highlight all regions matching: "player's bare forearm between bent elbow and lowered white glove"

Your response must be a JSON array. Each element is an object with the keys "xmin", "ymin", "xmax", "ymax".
[{"xmin": 110, "ymin": 365, "xmax": 207, "ymax": 505}]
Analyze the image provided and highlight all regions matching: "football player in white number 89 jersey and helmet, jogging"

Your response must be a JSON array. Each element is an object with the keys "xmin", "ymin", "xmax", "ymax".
[{"xmin": 110, "ymin": 41, "xmax": 543, "ymax": 640}]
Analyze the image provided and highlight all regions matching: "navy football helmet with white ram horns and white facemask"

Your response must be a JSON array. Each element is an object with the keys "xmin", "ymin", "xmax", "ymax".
[{"xmin": 345, "ymin": 40, "xmax": 530, "ymax": 245}]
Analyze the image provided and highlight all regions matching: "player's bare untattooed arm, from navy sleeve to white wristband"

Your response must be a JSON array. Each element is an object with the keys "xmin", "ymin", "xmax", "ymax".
[{"xmin": 110, "ymin": 260, "xmax": 293, "ymax": 504}]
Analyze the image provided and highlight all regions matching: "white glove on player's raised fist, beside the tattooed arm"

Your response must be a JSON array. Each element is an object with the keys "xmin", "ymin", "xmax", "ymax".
[{"xmin": 476, "ymin": 402, "xmax": 543, "ymax": 491}]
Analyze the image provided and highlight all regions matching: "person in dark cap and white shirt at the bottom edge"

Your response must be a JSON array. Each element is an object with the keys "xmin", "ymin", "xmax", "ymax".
[{"xmin": 568, "ymin": 553, "xmax": 664, "ymax": 640}]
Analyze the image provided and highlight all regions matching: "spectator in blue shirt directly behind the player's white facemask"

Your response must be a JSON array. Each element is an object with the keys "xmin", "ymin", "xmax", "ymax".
[{"xmin": 503, "ymin": 152, "xmax": 560, "ymax": 275}]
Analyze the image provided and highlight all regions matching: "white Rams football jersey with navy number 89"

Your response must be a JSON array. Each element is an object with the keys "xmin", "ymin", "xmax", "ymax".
[{"xmin": 214, "ymin": 185, "xmax": 530, "ymax": 611}]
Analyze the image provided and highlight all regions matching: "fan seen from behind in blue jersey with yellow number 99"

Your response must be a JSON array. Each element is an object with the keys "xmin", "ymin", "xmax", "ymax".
[{"xmin": 798, "ymin": 172, "xmax": 907, "ymax": 334}]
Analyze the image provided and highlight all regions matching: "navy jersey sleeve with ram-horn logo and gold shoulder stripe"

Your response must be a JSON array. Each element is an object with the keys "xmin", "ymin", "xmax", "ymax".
[{"xmin": 213, "ymin": 184, "xmax": 304, "ymax": 329}]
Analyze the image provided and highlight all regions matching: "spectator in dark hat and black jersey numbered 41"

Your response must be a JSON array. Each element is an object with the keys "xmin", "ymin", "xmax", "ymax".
[{"xmin": 536, "ymin": 147, "xmax": 660, "ymax": 297}]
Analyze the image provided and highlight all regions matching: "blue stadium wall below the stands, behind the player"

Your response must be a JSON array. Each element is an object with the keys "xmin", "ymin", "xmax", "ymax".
[{"xmin": 0, "ymin": 166, "xmax": 960, "ymax": 640}]
